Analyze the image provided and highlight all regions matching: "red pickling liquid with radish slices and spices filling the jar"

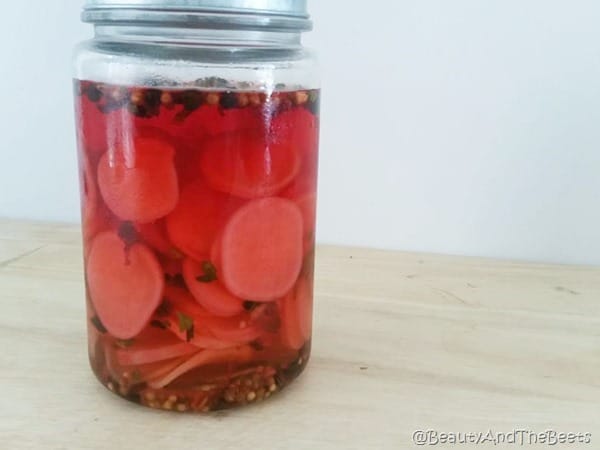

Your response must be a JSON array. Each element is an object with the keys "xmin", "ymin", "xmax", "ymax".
[{"xmin": 75, "ymin": 81, "xmax": 319, "ymax": 412}]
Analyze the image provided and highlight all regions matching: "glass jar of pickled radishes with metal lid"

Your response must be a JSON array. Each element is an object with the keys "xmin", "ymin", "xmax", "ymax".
[{"xmin": 74, "ymin": 0, "xmax": 320, "ymax": 412}]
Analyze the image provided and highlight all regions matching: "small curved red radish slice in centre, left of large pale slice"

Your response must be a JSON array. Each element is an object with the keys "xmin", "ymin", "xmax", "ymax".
[{"xmin": 183, "ymin": 258, "xmax": 244, "ymax": 317}]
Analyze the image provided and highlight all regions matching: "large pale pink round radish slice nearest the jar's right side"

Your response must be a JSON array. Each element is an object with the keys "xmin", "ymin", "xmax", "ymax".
[{"xmin": 221, "ymin": 198, "xmax": 303, "ymax": 302}]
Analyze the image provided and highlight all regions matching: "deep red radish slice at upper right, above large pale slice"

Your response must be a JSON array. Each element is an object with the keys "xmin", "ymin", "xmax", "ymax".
[{"xmin": 200, "ymin": 132, "xmax": 300, "ymax": 199}]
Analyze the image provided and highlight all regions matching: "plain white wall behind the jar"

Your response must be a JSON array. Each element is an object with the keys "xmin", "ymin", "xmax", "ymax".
[{"xmin": 0, "ymin": 0, "xmax": 600, "ymax": 264}]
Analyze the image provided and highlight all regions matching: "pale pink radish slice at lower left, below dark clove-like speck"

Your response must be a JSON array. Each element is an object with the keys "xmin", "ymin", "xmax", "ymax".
[{"xmin": 86, "ymin": 232, "xmax": 164, "ymax": 339}]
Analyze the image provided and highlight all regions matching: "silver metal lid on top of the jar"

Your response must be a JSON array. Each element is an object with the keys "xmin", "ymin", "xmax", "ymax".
[{"xmin": 82, "ymin": 0, "xmax": 312, "ymax": 31}]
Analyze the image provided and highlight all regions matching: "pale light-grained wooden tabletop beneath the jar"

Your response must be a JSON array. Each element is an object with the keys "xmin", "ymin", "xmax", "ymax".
[{"xmin": 0, "ymin": 221, "xmax": 600, "ymax": 450}]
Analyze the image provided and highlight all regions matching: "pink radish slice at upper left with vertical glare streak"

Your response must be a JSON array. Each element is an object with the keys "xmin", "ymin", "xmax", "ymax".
[{"xmin": 98, "ymin": 137, "xmax": 179, "ymax": 223}]
